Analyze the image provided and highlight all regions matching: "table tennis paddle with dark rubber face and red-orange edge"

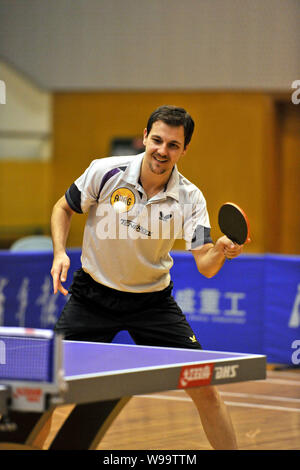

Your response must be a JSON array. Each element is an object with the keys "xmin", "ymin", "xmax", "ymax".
[{"xmin": 218, "ymin": 202, "xmax": 251, "ymax": 245}]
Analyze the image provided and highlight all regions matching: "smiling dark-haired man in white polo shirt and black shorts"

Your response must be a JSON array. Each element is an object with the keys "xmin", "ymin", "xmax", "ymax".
[{"xmin": 51, "ymin": 106, "xmax": 242, "ymax": 449}]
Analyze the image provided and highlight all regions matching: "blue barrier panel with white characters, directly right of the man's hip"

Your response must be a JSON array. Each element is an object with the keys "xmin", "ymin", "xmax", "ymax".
[{"xmin": 172, "ymin": 254, "xmax": 264, "ymax": 353}]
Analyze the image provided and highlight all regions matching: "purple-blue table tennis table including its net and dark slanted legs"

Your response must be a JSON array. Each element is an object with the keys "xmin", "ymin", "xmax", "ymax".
[{"xmin": 0, "ymin": 328, "xmax": 266, "ymax": 450}]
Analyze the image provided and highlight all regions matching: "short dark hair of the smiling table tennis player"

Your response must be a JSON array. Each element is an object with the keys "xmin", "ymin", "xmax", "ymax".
[{"xmin": 147, "ymin": 105, "xmax": 195, "ymax": 148}]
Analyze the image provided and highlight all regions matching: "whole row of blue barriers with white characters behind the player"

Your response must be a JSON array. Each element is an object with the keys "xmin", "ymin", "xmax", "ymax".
[{"xmin": 0, "ymin": 250, "xmax": 300, "ymax": 366}]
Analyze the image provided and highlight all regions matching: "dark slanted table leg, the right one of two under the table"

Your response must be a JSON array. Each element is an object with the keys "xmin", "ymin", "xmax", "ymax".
[{"xmin": 49, "ymin": 397, "xmax": 131, "ymax": 450}]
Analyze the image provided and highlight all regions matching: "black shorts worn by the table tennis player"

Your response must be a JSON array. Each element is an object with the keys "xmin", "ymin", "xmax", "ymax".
[{"xmin": 55, "ymin": 269, "xmax": 202, "ymax": 349}]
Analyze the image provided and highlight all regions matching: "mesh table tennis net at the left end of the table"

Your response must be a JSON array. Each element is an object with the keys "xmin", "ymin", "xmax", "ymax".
[{"xmin": 0, "ymin": 334, "xmax": 53, "ymax": 382}]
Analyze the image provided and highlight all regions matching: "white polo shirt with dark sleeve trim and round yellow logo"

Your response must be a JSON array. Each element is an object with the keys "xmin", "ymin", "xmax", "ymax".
[{"xmin": 66, "ymin": 153, "xmax": 212, "ymax": 292}]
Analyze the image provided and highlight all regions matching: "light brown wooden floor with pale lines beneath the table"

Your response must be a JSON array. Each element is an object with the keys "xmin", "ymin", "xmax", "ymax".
[{"xmin": 45, "ymin": 369, "xmax": 300, "ymax": 450}]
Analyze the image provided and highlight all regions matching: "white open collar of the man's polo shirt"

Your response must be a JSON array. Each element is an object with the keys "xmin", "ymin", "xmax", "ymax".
[{"xmin": 123, "ymin": 152, "xmax": 179, "ymax": 201}]
